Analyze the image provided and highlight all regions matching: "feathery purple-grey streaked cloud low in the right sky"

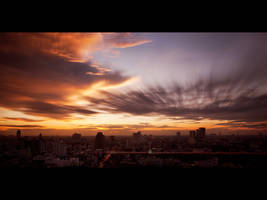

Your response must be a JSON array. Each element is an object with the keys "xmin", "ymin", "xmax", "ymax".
[{"xmin": 88, "ymin": 74, "xmax": 267, "ymax": 128}]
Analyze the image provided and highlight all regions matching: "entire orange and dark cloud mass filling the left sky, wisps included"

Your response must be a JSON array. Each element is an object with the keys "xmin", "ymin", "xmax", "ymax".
[{"xmin": 0, "ymin": 33, "xmax": 154, "ymax": 128}]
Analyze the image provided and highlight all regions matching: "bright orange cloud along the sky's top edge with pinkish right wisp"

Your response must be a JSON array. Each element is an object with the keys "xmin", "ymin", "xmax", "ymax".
[{"xmin": 3, "ymin": 33, "xmax": 152, "ymax": 62}]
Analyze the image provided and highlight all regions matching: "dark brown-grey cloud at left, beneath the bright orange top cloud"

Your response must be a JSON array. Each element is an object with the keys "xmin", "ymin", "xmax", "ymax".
[{"xmin": 0, "ymin": 33, "xmax": 131, "ymax": 118}]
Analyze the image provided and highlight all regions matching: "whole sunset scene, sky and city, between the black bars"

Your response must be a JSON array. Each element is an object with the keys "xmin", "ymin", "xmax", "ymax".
[{"xmin": 0, "ymin": 32, "xmax": 267, "ymax": 169}]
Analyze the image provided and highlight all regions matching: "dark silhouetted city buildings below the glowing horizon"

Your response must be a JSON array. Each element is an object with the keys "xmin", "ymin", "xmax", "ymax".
[{"xmin": 0, "ymin": 127, "xmax": 267, "ymax": 168}]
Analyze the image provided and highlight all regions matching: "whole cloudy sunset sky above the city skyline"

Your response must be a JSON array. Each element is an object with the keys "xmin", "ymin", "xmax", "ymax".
[{"xmin": 0, "ymin": 32, "xmax": 267, "ymax": 135}]
